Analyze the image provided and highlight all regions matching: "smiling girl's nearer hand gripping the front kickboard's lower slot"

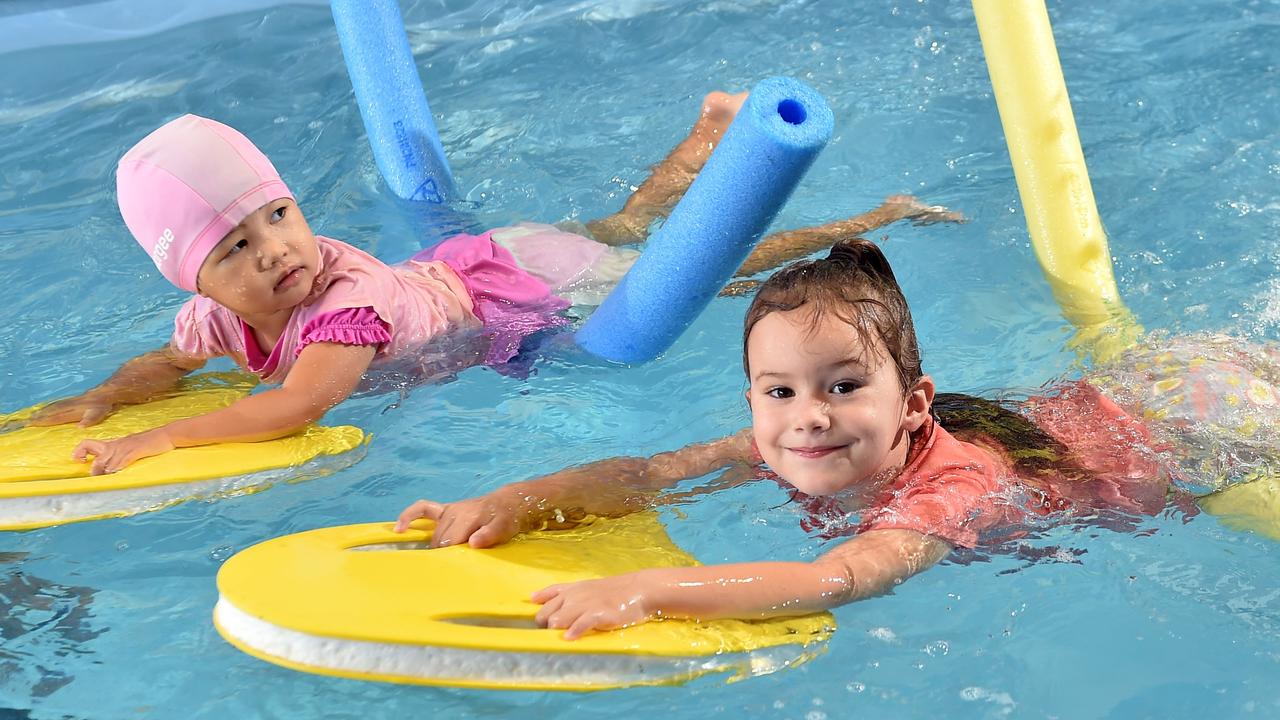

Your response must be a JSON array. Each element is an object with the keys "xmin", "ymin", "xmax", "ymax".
[{"xmin": 530, "ymin": 570, "xmax": 657, "ymax": 641}]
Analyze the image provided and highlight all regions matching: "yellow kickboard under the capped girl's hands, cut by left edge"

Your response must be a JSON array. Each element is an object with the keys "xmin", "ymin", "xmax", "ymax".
[{"xmin": 0, "ymin": 373, "xmax": 365, "ymax": 530}]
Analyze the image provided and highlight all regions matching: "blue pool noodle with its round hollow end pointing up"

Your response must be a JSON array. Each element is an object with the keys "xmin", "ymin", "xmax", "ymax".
[{"xmin": 576, "ymin": 77, "xmax": 835, "ymax": 363}]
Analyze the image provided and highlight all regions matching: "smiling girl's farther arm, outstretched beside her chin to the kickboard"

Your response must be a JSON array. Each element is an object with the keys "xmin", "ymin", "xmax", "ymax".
[{"xmin": 396, "ymin": 430, "xmax": 751, "ymax": 547}]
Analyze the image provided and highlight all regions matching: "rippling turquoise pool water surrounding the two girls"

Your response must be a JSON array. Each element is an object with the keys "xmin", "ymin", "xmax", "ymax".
[{"xmin": 0, "ymin": 0, "xmax": 1280, "ymax": 720}]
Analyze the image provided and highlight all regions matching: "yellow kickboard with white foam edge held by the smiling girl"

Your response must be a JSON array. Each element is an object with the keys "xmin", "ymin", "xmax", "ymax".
[{"xmin": 215, "ymin": 512, "xmax": 835, "ymax": 691}]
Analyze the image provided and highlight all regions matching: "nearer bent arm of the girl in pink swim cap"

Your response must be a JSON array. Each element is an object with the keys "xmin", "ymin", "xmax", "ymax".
[{"xmin": 72, "ymin": 342, "xmax": 378, "ymax": 475}]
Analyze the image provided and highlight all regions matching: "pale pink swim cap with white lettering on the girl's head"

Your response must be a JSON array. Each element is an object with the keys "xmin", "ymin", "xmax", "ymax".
[{"xmin": 115, "ymin": 115, "xmax": 293, "ymax": 292}]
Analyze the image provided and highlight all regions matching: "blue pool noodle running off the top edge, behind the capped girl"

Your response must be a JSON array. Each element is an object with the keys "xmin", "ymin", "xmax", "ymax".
[{"xmin": 329, "ymin": 0, "xmax": 454, "ymax": 205}]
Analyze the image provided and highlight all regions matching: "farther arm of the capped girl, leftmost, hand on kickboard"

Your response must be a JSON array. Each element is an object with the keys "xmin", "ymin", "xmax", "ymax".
[{"xmin": 28, "ymin": 346, "xmax": 205, "ymax": 428}]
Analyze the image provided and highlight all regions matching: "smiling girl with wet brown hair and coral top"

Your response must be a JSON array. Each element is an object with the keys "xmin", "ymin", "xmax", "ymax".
[{"xmin": 396, "ymin": 238, "xmax": 1280, "ymax": 639}]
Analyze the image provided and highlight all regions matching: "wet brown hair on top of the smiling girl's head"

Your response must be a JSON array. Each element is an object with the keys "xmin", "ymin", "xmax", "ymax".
[{"xmin": 742, "ymin": 237, "xmax": 924, "ymax": 393}]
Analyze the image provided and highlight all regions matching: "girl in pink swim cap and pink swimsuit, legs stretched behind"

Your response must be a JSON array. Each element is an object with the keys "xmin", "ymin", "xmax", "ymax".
[{"xmin": 32, "ymin": 92, "xmax": 959, "ymax": 474}]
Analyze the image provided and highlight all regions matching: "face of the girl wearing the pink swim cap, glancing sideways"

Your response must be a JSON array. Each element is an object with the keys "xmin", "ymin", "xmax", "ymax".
[{"xmin": 197, "ymin": 199, "xmax": 320, "ymax": 319}]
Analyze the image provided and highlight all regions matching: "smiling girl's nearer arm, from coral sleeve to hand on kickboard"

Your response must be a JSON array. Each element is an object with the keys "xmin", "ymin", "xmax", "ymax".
[{"xmin": 532, "ymin": 529, "xmax": 951, "ymax": 639}]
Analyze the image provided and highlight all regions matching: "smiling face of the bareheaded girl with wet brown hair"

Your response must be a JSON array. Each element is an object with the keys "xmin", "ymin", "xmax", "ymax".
[{"xmin": 746, "ymin": 307, "xmax": 933, "ymax": 496}]
